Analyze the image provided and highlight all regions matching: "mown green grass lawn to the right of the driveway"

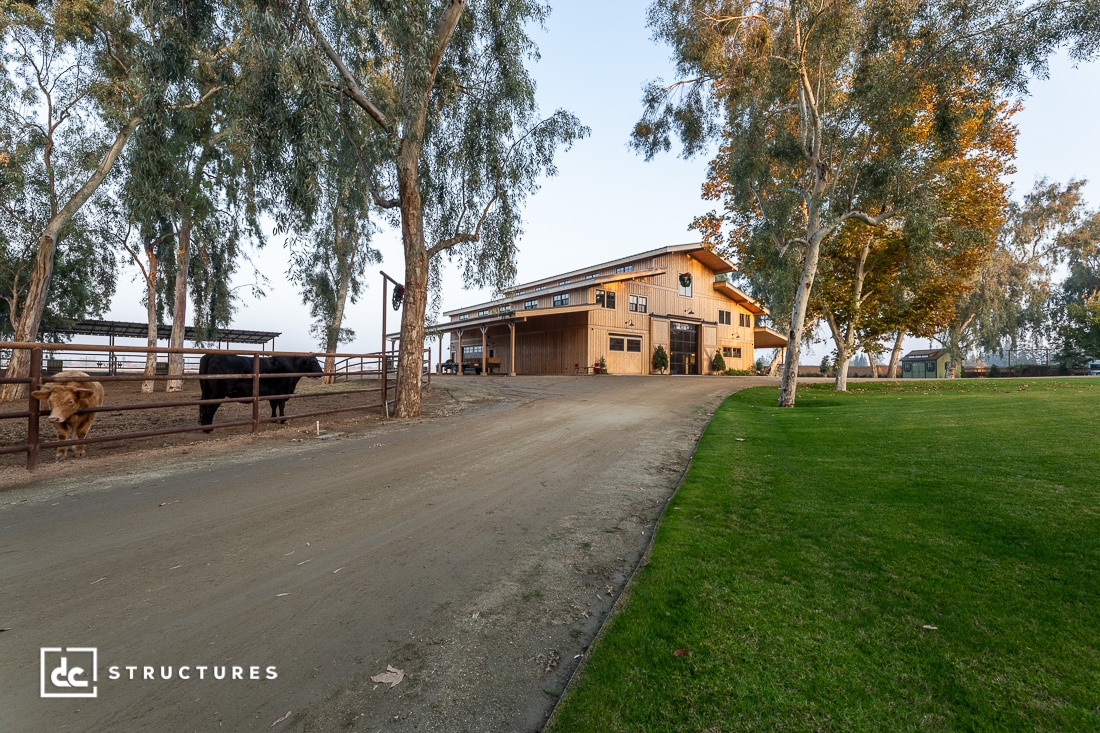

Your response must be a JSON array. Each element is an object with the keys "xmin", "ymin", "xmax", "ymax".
[{"xmin": 547, "ymin": 379, "xmax": 1100, "ymax": 733}]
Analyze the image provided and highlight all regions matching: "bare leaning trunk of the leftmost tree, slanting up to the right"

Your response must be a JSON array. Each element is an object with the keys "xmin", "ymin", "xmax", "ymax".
[{"xmin": 0, "ymin": 118, "xmax": 141, "ymax": 402}]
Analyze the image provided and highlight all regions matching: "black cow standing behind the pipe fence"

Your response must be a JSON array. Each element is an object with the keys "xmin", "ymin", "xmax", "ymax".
[{"xmin": 199, "ymin": 353, "xmax": 325, "ymax": 433}]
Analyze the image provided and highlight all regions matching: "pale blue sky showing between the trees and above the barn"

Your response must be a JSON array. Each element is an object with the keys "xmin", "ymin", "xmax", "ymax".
[{"xmin": 105, "ymin": 0, "xmax": 1100, "ymax": 363}]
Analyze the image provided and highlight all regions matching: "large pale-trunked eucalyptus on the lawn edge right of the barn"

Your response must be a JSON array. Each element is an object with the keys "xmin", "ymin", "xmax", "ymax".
[{"xmin": 633, "ymin": 0, "xmax": 1100, "ymax": 406}]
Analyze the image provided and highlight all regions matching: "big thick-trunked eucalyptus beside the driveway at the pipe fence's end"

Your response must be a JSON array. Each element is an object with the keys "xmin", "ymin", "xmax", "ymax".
[{"xmin": 279, "ymin": 0, "xmax": 587, "ymax": 417}]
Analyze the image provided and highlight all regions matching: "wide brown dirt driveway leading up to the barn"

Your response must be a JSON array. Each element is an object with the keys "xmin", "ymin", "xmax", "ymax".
[{"xmin": 0, "ymin": 376, "xmax": 768, "ymax": 732}]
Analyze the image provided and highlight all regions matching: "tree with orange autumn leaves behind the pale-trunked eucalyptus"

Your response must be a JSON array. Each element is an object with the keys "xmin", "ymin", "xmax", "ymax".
[{"xmin": 813, "ymin": 90, "xmax": 1016, "ymax": 391}]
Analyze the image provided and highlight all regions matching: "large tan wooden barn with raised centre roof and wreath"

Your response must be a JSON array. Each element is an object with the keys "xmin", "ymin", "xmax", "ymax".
[{"xmin": 433, "ymin": 244, "xmax": 787, "ymax": 374}]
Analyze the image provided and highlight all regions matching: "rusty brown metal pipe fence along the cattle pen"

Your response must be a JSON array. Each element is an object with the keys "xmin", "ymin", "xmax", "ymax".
[{"xmin": 0, "ymin": 341, "xmax": 431, "ymax": 470}]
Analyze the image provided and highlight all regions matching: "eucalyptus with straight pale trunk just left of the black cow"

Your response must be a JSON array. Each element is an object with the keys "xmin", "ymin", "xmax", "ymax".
[{"xmin": 123, "ymin": 1, "xmax": 253, "ymax": 391}]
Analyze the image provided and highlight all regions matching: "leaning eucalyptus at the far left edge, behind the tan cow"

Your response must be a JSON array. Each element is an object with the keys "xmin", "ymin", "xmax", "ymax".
[{"xmin": 0, "ymin": 2, "xmax": 141, "ymax": 401}]
